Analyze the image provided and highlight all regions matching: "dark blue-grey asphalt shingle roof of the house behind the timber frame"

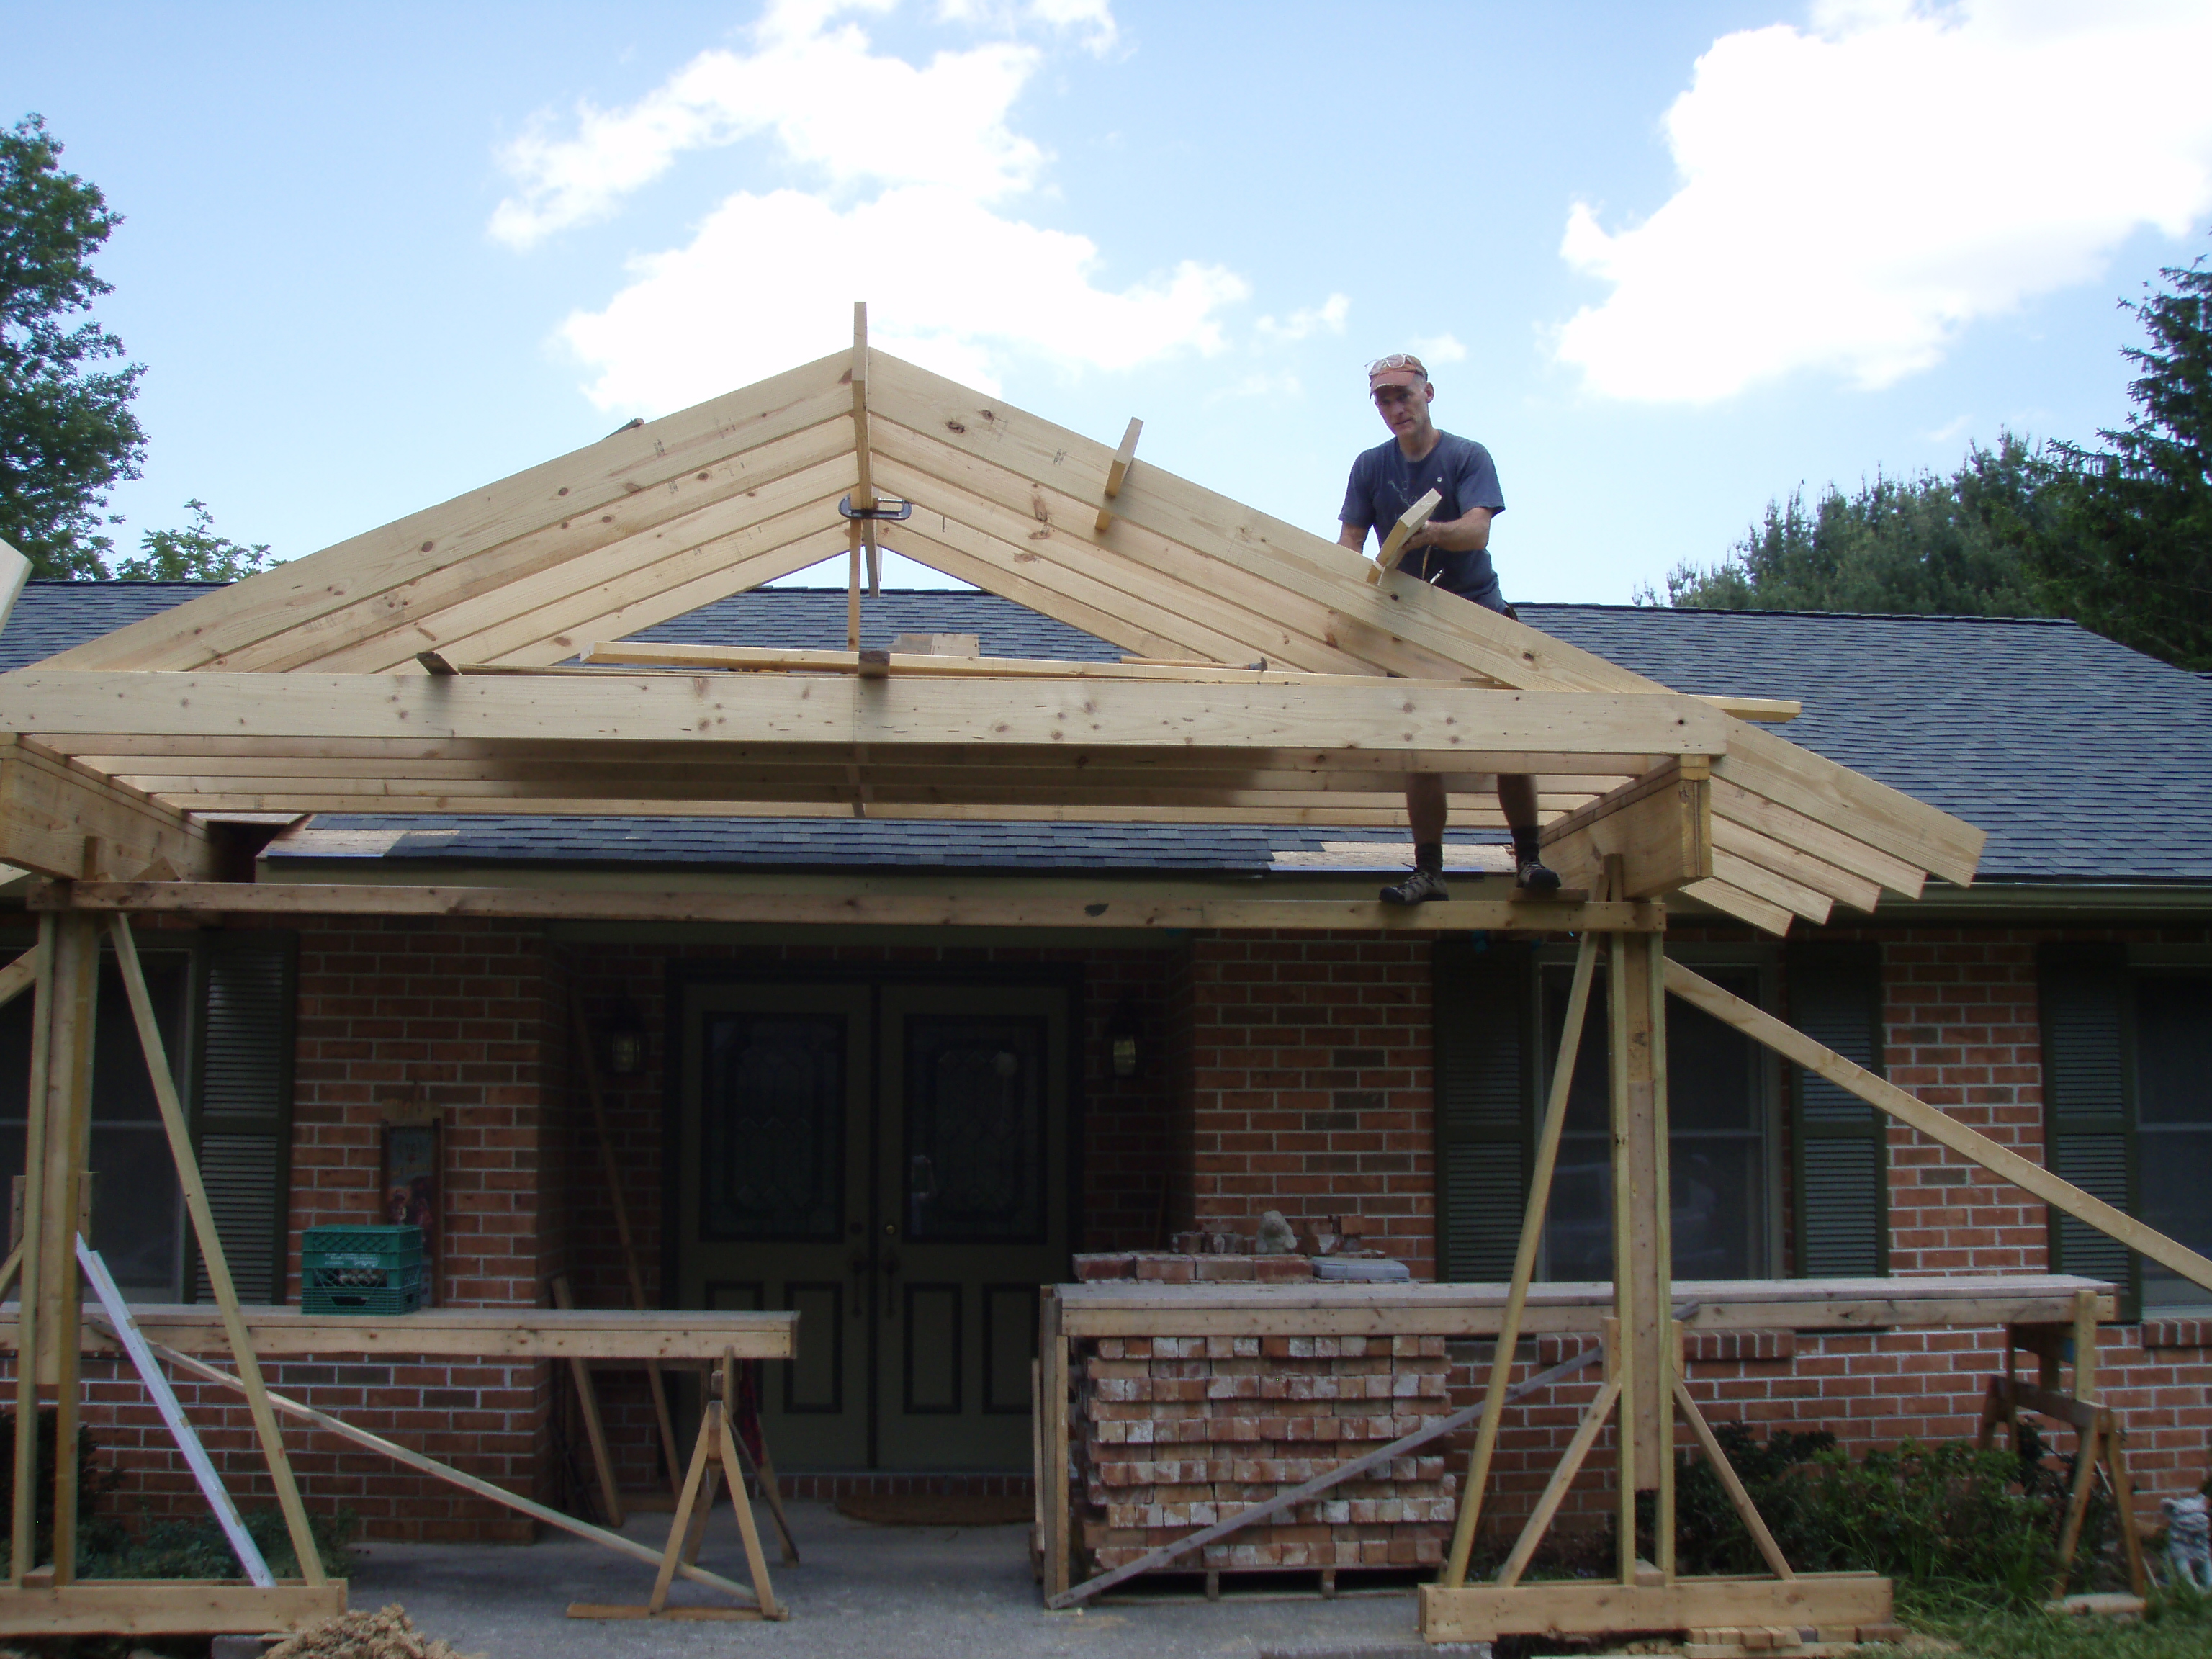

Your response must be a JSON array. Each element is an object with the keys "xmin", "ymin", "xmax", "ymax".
[{"xmin": 0, "ymin": 582, "xmax": 2212, "ymax": 883}]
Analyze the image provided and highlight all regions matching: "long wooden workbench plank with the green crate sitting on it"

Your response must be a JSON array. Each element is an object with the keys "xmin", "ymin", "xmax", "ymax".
[{"xmin": 0, "ymin": 1303, "xmax": 799, "ymax": 1360}]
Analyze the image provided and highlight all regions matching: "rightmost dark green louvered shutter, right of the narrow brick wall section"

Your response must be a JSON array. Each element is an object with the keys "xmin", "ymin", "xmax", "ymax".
[{"xmin": 2041, "ymin": 945, "xmax": 2141, "ymax": 1318}]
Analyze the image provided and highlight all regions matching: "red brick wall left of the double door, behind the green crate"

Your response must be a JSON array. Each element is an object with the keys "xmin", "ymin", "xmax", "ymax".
[{"xmin": 86, "ymin": 918, "xmax": 566, "ymax": 1539}]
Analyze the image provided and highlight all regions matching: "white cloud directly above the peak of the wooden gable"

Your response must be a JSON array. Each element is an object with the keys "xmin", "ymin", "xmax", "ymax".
[{"xmin": 508, "ymin": 0, "xmax": 1256, "ymax": 411}]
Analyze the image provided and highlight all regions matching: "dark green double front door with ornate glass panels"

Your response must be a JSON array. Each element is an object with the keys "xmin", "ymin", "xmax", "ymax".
[{"xmin": 673, "ymin": 982, "xmax": 1069, "ymax": 1469}]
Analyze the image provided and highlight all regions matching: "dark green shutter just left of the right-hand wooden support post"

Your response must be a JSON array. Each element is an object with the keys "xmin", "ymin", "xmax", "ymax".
[{"xmin": 1436, "ymin": 940, "xmax": 1533, "ymax": 1281}]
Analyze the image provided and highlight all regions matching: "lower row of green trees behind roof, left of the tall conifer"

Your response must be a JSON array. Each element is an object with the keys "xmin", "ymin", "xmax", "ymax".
[{"xmin": 1637, "ymin": 433, "xmax": 2051, "ymax": 617}]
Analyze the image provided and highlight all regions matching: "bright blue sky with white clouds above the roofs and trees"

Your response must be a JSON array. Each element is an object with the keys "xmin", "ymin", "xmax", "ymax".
[{"xmin": 0, "ymin": 0, "xmax": 2212, "ymax": 604}]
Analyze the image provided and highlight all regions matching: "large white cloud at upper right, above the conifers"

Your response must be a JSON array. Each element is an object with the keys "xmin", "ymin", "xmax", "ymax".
[{"xmin": 1557, "ymin": 0, "xmax": 2212, "ymax": 403}]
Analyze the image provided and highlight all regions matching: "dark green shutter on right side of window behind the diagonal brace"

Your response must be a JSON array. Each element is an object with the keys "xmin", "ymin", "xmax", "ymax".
[{"xmin": 1789, "ymin": 943, "xmax": 1889, "ymax": 1279}]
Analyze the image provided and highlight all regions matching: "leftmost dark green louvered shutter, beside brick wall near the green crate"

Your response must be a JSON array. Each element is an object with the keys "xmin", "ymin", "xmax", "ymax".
[{"xmin": 192, "ymin": 933, "xmax": 297, "ymax": 1303}]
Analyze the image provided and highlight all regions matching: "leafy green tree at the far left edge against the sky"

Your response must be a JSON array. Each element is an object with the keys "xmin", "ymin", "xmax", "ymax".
[{"xmin": 0, "ymin": 115, "xmax": 146, "ymax": 580}]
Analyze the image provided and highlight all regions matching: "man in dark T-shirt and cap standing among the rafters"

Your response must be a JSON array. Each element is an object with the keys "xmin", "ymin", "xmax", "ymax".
[{"xmin": 1336, "ymin": 351, "xmax": 1560, "ymax": 904}]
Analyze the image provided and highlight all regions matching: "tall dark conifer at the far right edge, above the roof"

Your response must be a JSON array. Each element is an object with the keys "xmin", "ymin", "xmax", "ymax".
[{"xmin": 2013, "ymin": 258, "xmax": 2212, "ymax": 673}]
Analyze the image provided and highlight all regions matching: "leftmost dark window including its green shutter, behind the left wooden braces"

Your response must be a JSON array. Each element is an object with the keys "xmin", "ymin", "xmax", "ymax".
[{"xmin": 0, "ymin": 931, "xmax": 292, "ymax": 1303}]
